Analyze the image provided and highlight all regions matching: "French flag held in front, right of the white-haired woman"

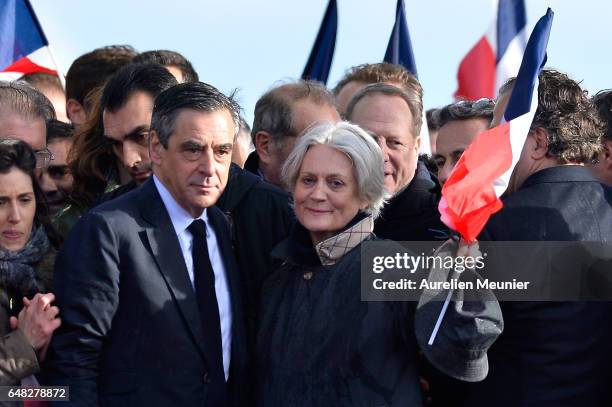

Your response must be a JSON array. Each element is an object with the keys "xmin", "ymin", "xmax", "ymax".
[{"xmin": 438, "ymin": 8, "xmax": 554, "ymax": 242}]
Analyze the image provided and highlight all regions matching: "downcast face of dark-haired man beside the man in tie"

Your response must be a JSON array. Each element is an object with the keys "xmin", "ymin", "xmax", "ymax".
[{"xmin": 102, "ymin": 91, "xmax": 153, "ymax": 184}]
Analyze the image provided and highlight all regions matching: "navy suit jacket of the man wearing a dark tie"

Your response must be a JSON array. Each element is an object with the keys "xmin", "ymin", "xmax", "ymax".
[{"xmin": 46, "ymin": 179, "xmax": 246, "ymax": 407}]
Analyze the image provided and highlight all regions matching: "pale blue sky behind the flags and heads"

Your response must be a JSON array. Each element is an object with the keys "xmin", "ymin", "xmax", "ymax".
[{"xmin": 31, "ymin": 0, "xmax": 612, "ymax": 121}]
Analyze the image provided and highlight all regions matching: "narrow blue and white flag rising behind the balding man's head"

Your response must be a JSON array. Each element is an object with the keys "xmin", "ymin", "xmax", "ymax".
[{"xmin": 383, "ymin": 0, "xmax": 431, "ymax": 154}]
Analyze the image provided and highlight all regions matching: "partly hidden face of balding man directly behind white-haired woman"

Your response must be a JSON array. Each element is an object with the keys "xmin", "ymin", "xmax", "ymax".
[{"xmin": 264, "ymin": 99, "xmax": 340, "ymax": 186}]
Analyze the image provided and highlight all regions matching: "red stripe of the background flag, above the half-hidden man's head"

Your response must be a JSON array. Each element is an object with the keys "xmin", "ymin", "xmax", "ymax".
[{"xmin": 455, "ymin": 36, "xmax": 495, "ymax": 100}]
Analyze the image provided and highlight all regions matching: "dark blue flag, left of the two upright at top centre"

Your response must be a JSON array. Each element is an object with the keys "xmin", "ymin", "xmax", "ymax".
[{"xmin": 302, "ymin": 0, "xmax": 338, "ymax": 83}]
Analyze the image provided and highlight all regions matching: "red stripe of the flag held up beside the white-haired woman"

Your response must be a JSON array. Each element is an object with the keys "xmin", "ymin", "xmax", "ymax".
[{"xmin": 438, "ymin": 123, "xmax": 512, "ymax": 242}]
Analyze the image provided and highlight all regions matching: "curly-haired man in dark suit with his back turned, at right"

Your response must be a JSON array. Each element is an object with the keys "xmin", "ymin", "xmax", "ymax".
[{"xmin": 460, "ymin": 70, "xmax": 612, "ymax": 407}]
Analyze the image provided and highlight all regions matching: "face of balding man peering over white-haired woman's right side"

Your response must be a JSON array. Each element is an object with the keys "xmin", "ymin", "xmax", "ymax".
[{"xmin": 350, "ymin": 94, "xmax": 421, "ymax": 194}]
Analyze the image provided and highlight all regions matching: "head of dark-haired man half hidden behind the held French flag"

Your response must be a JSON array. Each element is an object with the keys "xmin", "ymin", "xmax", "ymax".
[{"xmin": 433, "ymin": 99, "xmax": 495, "ymax": 185}]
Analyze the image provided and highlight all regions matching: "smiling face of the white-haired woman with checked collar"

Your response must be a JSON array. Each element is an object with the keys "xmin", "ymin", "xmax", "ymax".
[{"xmin": 293, "ymin": 145, "xmax": 368, "ymax": 244}]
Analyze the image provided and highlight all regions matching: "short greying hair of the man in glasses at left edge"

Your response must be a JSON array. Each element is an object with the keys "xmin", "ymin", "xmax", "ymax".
[{"xmin": 0, "ymin": 81, "xmax": 55, "ymax": 122}]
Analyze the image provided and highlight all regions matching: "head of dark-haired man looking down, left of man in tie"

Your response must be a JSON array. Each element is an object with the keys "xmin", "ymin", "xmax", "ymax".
[{"xmin": 100, "ymin": 64, "xmax": 177, "ymax": 200}]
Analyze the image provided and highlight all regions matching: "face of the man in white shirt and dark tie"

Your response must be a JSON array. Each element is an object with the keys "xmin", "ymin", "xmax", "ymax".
[{"xmin": 151, "ymin": 109, "xmax": 234, "ymax": 218}]
